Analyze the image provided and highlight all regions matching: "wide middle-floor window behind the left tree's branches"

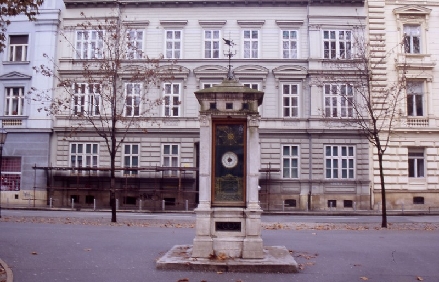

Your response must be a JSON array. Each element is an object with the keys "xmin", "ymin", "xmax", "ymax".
[{"xmin": 72, "ymin": 83, "xmax": 101, "ymax": 116}]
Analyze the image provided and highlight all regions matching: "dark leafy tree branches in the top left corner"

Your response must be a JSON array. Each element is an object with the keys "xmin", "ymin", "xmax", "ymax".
[{"xmin": 0, "ymin": 0, "xmax": 44, "ymax": 53}]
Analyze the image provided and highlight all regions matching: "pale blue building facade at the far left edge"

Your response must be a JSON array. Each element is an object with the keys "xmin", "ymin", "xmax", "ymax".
[{"xmin": 0, "ymin": 0, "xmax": 63, "ymax": 207}]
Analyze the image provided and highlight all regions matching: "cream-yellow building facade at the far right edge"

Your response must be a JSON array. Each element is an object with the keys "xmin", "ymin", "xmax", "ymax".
[{"xmin": 368, "ymin": 0, "xmax": 439, "ymax": 210}]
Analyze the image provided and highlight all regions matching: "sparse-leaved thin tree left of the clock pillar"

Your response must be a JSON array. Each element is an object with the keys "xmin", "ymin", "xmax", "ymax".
[{"xmin": 32, "ymin": 9, "xmax": 172, "ymax": 222}]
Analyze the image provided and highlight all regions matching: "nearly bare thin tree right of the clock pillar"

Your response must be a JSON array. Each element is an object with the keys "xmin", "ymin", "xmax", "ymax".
[{"xmin": 321, "ymin": 27, "xmax": 407, "ymax": 228}]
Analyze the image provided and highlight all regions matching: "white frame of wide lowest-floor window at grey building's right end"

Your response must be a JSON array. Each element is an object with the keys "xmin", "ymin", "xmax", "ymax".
[{"xmin": 324, "ymin": 145, "xmax": 357, "ymax": 180}]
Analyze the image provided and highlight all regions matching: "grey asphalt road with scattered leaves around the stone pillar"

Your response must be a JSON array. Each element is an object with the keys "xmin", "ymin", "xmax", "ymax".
[{"xmin": 0, "ymin": 211, "xmax": 439, "ymax": 282}]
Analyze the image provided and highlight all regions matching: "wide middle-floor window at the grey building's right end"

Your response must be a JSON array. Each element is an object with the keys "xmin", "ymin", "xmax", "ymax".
[{"xmin": 323, "ymin": 84, "xmax": 354, "ymax": 118}]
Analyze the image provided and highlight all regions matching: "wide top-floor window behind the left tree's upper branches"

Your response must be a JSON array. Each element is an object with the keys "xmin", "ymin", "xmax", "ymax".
[{"xmin": 76, "ymin": 30, "xmax": 104, "ymax": 59}]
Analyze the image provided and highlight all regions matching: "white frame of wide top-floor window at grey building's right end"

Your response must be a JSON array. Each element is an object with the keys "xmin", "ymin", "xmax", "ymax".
[{"xmin": 322, "ymin": 29, "xmax": 353, "ymax": 60}]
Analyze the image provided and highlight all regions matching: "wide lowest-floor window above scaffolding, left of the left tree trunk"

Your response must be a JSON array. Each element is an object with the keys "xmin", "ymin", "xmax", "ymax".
[{"xmin": 70, "ymin": 143, "xmax": 99, "ymax": 174}]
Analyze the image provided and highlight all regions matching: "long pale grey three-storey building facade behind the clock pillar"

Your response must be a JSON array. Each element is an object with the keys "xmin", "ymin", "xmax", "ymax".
[{"xmin": 42, "ymin": 0, "xmax": 373, "ymax": 210}]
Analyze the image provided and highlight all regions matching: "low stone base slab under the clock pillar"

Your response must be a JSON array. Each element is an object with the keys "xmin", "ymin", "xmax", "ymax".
[{"xmin": 156, "ymin": 245, "xmax": 299, "ymax": 273}]
